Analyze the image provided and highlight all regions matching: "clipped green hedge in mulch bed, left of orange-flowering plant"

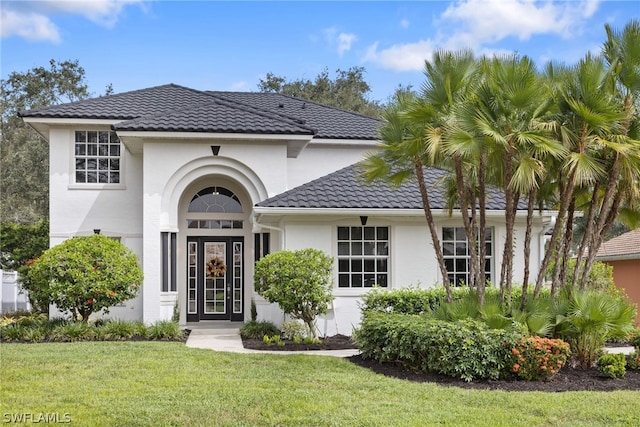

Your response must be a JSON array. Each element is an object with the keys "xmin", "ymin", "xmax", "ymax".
[{"xmin": 354, "ymin": 313, "xmax": 524, "ymax": 381}]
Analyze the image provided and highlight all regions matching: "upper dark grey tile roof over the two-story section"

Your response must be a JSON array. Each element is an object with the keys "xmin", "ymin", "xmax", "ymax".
[{"xmin": 20, "ymin": 84, "xmax": 381, "ymax": 140}]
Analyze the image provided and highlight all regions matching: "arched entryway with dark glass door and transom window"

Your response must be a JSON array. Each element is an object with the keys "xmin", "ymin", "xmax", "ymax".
[{"xmin": 180, "ymin": 178, "xmax": 251, "ymax": 322}]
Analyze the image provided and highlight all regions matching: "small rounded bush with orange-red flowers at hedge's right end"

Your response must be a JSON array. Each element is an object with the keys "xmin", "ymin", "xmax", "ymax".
[{"xmin": 510, "ymin": 336, "xmax": 571, "ymax": 381}]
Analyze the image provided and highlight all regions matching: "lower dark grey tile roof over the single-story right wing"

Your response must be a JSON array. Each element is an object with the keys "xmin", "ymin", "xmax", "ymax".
[{"xmin": 256, "ymin": 163, "xmax": 526, "ymax": 210}]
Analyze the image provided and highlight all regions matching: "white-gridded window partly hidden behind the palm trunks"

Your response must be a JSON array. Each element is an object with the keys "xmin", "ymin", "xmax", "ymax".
[{"xmin": 442, "ymin": 227, "xmax": 493, "ymax": 286}]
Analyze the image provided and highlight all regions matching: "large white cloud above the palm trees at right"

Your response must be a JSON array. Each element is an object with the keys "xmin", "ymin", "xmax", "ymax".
[{"xmin": 363, "ymin": 0, "xmax": 601, "ymax": 71}]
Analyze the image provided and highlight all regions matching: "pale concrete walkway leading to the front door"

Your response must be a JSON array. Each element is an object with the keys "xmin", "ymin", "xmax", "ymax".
[{"xmin": 186, "ymin": 325, "xmax": 360, "ymax": 357}]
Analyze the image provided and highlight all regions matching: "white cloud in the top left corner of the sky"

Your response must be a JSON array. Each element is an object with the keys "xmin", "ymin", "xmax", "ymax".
[{"xmin": 0, "ymin": 0, "xmax": 144, "ymax": 43}]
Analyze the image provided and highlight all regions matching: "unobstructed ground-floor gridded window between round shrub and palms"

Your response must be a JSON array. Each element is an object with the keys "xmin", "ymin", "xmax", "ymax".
[{"xmin": 338, "ymin": 227, "xmax": 389, "ymax": 288}]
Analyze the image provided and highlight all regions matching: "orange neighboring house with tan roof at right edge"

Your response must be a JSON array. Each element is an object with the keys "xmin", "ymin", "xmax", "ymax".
[{"xmin": 596, "ymin": 229, "xmax": 640, "ymax": 325}]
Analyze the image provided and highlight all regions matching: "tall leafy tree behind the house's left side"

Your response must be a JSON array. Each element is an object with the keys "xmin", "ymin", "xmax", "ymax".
[{"xmin": 0, "ymin": 59, "xmax": 89, "ymax": 224}]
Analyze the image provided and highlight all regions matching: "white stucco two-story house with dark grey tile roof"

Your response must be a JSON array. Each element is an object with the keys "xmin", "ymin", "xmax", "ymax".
[{"xmin": 21, "ymin": 84, "xmax": 550, "ymax": 335}]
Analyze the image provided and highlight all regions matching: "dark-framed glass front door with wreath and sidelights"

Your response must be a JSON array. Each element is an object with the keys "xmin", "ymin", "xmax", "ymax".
[{"xmin": 187, "ymin": 237, "xmax": 244, "ymax": 322}]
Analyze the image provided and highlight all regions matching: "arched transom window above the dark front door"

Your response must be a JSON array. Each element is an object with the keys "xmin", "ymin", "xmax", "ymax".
[{"xmin": 187, "ymin": 187, "xmax": 243, "ymax": 229}]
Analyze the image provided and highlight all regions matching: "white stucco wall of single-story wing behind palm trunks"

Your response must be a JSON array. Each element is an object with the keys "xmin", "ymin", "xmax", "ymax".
[{"xmin": 259, "ymin": 214, "xmax": 542, "ymax": 335}]
